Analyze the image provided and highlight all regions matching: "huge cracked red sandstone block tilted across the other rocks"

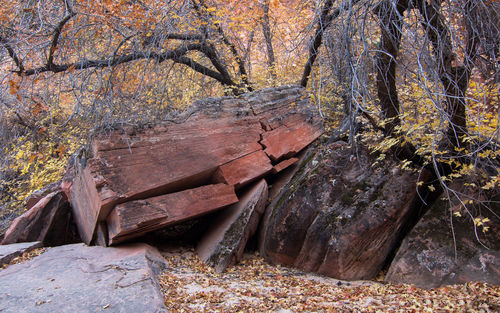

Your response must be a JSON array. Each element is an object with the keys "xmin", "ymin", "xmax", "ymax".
[{"xmin": 64, "ymin": 86, "xmax": 323, "ymax": 244}]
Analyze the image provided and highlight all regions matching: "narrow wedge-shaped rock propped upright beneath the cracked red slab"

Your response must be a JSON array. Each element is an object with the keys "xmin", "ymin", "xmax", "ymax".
[{"xmin": 196, "ymin": 179, "xmax": 267, "ymax": 273}]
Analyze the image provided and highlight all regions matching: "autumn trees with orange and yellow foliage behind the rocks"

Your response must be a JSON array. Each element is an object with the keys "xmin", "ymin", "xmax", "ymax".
[{"xmin": 0, "ymin": 0, "xmax": 500, "ymax": 230}]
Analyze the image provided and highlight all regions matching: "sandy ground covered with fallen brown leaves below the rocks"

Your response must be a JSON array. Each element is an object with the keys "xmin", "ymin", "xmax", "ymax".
[{"xmin": 160, "ymin": 244, "xmax": 500, "ymax": 313}]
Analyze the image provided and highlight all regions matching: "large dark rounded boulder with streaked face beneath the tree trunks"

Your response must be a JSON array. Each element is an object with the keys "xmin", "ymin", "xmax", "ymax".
[{"xmin": 259, "ymin": 142, "xmax": 430, "ymax": 280}]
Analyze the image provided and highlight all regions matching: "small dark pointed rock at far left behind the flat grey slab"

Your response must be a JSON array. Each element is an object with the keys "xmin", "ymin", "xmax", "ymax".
[{"xmin": 2, "ymin": 190, "xmax": 81, "ymax": 246}]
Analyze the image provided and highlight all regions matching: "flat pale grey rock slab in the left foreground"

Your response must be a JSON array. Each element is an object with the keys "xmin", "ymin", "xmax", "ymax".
[{"xmin": 0, "ymin": 244, "xmax": 167, "ymax": 313}]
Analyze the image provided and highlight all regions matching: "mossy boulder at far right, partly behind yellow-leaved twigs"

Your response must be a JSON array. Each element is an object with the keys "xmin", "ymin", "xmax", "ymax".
[{"xmin": 386, "ymin": 183, "xmax": 500, "ymax": 288}]
